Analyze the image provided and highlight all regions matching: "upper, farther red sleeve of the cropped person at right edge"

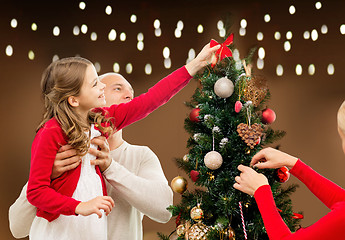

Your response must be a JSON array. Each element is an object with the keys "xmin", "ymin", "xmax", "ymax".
[{"xmin": 290, "ymin": 160, "xmax": 345, "ymax": 208}]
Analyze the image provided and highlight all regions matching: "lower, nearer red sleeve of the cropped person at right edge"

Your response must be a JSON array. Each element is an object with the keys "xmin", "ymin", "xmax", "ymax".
[{"xmin": 254, "ymin": 185, "xmax": 345, "ymax": 240}]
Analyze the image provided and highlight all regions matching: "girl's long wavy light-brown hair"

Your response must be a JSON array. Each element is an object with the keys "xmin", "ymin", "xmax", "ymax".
[{"xmin": 36, "ymin": 57, "xmax": 113, "ymax": 155}]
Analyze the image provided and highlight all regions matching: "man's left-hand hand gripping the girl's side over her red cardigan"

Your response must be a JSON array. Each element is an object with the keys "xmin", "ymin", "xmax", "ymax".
[{"xmin": 50, "ymin": 145, "xmax": 81, "ymax": 179}]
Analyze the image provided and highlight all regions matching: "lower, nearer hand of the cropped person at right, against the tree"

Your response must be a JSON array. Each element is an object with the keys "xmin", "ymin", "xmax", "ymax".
[{"xmin": 234, "ymin": 165, "xmax": 268, "ymax": 196}]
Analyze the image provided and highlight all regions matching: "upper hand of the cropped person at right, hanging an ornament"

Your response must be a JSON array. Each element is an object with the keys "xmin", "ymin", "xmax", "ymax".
[{"xmin": 250, "ymin": 148, "xmax": 298, "ymax": 169}]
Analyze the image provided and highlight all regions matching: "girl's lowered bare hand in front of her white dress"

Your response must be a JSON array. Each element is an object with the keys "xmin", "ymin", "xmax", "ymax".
[{"xmin": 75, "ymin": 196, "xmax": 115, "ymax": 218}]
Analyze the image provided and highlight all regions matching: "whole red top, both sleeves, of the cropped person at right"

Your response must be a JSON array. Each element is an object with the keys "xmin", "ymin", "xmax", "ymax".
[{"xmin": 254, "ymin": 160, "xmax": 345, "ymax": 240}]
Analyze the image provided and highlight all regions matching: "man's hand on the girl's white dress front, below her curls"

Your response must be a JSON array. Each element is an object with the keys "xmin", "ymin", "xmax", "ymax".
[{"xmin": 89, "ymin": 136, "xmax": 112, "ymax": 172}]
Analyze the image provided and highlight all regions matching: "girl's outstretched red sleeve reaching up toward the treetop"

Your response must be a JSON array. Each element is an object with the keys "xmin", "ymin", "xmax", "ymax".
[{"xmin": 104, "ymin": 67, "xmax": 192, "ymax": 130}]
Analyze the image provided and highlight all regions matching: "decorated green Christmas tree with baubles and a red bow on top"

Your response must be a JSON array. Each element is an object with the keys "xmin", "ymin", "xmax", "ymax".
[{"xmin": 158, "ymin": 32, "xmax": 301, "ymax": 240}]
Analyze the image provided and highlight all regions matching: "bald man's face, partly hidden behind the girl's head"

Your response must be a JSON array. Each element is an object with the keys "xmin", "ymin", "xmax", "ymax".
[{"xmin": 101, "ymin": 73, "xmax": 134, "ymax": 106}]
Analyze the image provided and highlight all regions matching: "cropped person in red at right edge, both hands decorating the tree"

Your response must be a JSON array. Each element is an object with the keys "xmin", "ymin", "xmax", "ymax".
[{"xmin": 234, "ymin": 102, "xmax": 345, "ymax": 240}]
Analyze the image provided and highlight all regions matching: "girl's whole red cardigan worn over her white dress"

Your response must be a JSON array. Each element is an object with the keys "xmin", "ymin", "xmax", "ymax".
[{"xmin": 27, "ymin": 67, "xmax": 191, "ymax": 221}]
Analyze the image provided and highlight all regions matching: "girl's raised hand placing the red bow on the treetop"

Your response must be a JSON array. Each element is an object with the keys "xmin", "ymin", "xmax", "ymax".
[{"xmin": 186, "ymin": 43, "xmax": 220, "ymax": 76}]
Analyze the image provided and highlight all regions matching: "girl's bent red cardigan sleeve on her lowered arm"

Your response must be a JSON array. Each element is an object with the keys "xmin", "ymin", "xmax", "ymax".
[{"xmin": 27, "ymin": 119, "xmax": 80, "ymax": 215}]
